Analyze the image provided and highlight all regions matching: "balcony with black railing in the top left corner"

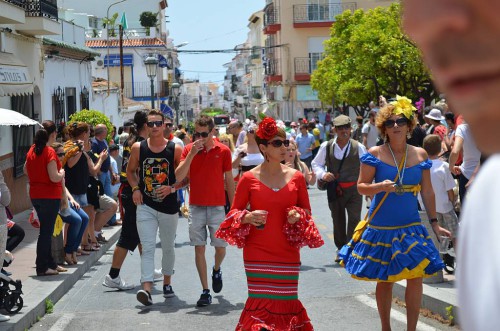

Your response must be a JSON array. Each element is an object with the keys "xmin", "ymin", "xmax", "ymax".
[{"xmin": 16, "ymin": 0, "xmax": 61, "ymax": 36}]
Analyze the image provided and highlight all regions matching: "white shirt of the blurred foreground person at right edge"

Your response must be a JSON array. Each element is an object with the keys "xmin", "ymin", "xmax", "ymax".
[{"xmin": 457, "ymin": 154, "xmax": 500, "ymax": 331}]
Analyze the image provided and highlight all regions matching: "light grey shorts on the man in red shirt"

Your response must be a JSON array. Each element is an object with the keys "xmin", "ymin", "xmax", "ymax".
[{"xmin": 188, "ymin": 205, "xmax": 227, "ymax": 247}]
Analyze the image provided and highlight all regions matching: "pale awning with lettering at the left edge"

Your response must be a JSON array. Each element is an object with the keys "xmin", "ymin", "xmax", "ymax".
[{"xmin": 0, "ymin": 53, "xmax": 33, "ymax": 97}]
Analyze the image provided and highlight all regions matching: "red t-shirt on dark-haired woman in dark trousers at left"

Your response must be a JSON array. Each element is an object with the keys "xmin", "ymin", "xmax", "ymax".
[{"xmin": 26, "ymin": 145, "xmax": 62, "ymax": 199}]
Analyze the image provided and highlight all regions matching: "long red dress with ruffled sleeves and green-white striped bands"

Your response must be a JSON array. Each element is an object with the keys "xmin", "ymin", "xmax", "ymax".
[{"xmin": 216, "ymin": 171, "xmax": 324, "ymax": 331}]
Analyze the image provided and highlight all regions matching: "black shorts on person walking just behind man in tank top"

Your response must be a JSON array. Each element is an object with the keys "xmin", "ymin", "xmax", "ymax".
[{"xmin": 116, "ymin": 185, "xmax": 141, "ymax": 252}]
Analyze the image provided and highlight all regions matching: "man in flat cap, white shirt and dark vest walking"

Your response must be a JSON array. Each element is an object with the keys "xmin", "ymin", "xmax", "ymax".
[{"xmin": 312, "ymin": 115, "xmax": 366, "ymax": 262}]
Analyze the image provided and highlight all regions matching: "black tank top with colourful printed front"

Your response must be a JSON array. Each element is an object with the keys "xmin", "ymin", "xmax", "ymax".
[{"xmin": 139, "ymin": 140, "xmax": 179, "ymax": 214}]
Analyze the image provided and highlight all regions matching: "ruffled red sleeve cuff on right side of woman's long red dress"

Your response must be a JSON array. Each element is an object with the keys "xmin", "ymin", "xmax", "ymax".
[{"xmin": 283, "ymin": 207, "xmax": 325, "ymax": 248}]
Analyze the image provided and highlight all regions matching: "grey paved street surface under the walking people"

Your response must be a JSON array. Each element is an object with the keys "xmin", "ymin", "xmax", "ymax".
[{"xmin": 31, "ymin": 188, "xmax": 455, "ymax": 331}]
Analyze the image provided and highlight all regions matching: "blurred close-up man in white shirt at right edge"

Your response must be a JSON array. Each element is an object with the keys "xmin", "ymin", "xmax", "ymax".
[{"xmin": 402, "ymin": 0, "xmax": 500, "ymax": 331}]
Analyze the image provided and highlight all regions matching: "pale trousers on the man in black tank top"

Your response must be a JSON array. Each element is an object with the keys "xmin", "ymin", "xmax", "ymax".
[{"xmin": 137, "ymin": 205, "xmax": 179, "ymax": 283}]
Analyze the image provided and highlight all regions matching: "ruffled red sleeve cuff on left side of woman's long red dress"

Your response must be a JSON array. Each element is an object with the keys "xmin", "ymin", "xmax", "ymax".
[{"xmin": 215, "ymin": 210, "xmax": 251, "ymax": 248}]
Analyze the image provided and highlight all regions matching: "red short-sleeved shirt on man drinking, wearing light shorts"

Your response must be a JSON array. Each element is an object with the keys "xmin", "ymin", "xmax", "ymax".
[{"xmin": 181, "ymin": 140, "xmax": 232, "ymax": 206}]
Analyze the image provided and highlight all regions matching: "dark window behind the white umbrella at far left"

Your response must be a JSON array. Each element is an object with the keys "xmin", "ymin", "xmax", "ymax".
[{"xmin": 11, "ymin": 95, "xmax": 35, "ymax": 178}]
